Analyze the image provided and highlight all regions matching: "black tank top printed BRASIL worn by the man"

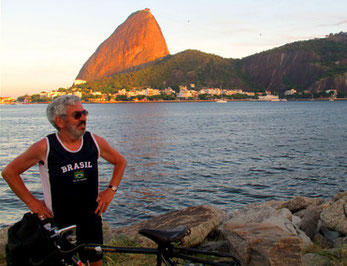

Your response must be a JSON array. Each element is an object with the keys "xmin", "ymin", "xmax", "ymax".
[{"xmin": 47, "ymin": 131, "xmax": 99, "ymax": 223}]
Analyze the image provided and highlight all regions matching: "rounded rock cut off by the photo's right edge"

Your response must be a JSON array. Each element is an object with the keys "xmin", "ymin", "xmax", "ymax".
[{"xmin": 320, "ymin": 198, "xmax": 347, "ymax": 235}]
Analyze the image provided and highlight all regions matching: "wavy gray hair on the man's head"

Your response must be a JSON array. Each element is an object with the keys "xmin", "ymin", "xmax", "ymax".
[{"xmin": 46, "ymin": 95, "xmax": 81, "ymax": 130}]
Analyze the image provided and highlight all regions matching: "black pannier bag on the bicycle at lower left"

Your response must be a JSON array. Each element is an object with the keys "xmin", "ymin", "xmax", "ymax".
[{"xmin": 6, "ymin": 212, "xmax": 61, "ymax": 266}]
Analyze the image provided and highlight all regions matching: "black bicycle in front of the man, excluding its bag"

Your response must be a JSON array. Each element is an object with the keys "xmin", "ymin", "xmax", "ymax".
[{"xmin": 50, "ymin": 223, "xmax": 240, "ymax": 266}]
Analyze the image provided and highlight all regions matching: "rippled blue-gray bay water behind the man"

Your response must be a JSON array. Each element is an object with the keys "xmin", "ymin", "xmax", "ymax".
[{"xmin": 0, "ymin": 101, "xmax": 347, "ymax": 227}]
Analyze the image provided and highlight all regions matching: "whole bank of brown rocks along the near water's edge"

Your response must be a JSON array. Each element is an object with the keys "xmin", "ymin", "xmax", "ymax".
[{"xmin": 0, "ymin": 191, "xmax": 347, "ymax": 266}]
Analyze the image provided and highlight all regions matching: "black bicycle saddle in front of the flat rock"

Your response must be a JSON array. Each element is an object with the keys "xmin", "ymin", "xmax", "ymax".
[{"xmin": 139, "ymin": 226, "xmax": 190, "ymax": 245}]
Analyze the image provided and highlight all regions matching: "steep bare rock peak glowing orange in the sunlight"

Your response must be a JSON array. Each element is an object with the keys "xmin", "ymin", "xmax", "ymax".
[{"xmin": 76, "ymin": 8, "xmax": 169, "ymax": 81}]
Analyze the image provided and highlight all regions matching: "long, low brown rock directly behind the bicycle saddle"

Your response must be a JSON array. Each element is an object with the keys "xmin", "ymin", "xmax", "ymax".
[{"xmin": 112, "ymin": 205, "xmax": 227, "ymax": 246}]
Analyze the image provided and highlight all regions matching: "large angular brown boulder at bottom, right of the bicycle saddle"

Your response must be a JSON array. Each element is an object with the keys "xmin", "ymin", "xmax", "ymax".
[{"xmin": 223, "ymin": 221, "xmax": 302, "ymax": 266}]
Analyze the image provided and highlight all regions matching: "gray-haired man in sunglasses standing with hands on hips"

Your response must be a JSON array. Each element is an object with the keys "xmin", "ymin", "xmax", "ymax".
[{"xmin": 2, "ymin": 95, "xmax": 126, "ymax": 265}]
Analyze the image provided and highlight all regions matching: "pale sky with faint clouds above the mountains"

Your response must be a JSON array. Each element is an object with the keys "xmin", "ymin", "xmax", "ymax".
[{"xmin": 0, "ymin": 0, "xmax": 347, "ymax": 97}]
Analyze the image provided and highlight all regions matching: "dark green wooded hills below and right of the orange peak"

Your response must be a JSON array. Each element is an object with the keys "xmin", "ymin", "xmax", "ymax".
[{"xmin": 79, "ymin": 33, "xmax": 347, "ymax": 93}]
